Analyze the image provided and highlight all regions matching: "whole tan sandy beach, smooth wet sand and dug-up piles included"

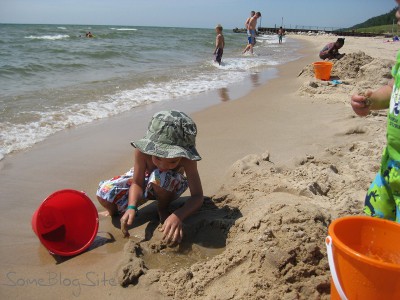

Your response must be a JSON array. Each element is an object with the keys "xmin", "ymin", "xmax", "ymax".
[{"xmin": 0, "ymin": 35, "xmax": 398, "ymax": 299}]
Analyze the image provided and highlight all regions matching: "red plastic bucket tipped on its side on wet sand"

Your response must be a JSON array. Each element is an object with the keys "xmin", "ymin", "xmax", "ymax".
[{"xmin": 32, "ymin": 190, "xmax": 99, "ymax": 256}]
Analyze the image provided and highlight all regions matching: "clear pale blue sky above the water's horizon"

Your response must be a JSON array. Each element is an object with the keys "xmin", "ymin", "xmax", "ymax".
[{"xmin": 0, "ymin": 0, "xmax": 396, "ymax": 30}]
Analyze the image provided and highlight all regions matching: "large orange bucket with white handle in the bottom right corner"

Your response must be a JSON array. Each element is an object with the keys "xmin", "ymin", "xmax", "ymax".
[{"xmin": 325, "ymin": 216, "xmax": 400, "ymax": 300}]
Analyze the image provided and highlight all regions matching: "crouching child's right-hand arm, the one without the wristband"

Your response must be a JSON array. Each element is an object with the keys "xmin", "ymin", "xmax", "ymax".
[{"xmin": 161, "ymin": 159, "xmax": 204, "ymax": 243}]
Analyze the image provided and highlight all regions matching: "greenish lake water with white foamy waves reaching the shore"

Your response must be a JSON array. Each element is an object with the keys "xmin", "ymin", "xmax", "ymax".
[{"xmin": 0, "ymin": 24, "xmax": 300, "ymax": 159}]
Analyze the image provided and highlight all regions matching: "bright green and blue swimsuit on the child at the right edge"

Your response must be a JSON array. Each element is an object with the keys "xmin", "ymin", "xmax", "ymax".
[{"xmin": 364, "ymin": 51, "xmax": 400, "ymax": 223}]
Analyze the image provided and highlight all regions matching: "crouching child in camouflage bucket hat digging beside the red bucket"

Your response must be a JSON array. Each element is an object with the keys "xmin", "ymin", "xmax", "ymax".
[{"xmin": 96, "ymin": 110, "xmax": 203, "ymax": 243}]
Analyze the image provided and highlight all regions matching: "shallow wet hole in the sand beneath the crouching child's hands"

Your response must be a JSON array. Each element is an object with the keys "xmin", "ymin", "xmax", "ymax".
[{"xmin": 117, "ymin": 201, "xmax": 240, "ymax": 287}]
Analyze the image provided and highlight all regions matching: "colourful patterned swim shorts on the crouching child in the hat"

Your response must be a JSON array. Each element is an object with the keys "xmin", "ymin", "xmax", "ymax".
[{"xmin": 96, "ymin": 169, "xmax": 188, "ymax": 214}]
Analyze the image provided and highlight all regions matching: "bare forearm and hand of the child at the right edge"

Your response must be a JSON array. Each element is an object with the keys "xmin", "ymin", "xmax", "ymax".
[{"xmin": 351, "ymin": 79, "xmax": 394, "ymax": 117}]
